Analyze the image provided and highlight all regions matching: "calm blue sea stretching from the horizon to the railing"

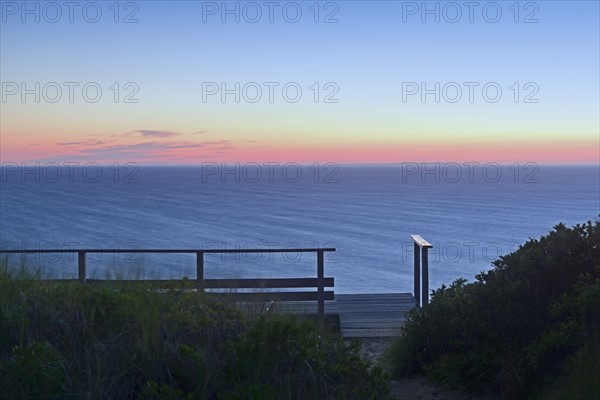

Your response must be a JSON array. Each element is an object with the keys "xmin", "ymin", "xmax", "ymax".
[{"xmin": 0, "ymin": 163, "xmax": 600, "ymax": 293}]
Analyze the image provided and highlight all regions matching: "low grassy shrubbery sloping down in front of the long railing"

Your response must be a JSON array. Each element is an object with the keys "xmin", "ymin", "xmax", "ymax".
[{"xmin": 0, "ymin": 272, "xmax": 389, "ymax": 400}]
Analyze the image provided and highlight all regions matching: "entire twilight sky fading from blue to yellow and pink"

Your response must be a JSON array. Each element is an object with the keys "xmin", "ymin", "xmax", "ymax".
[{"xmin": 0, "ymin": 0, "xmax": 600, "ymax": 165}]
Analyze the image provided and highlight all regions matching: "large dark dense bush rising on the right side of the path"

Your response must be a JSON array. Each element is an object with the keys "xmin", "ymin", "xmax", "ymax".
[{"xmin": 388, "ymin": 222, "xmax": 600, "ymax": 398}]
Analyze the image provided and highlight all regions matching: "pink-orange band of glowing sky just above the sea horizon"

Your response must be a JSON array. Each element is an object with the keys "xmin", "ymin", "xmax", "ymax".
[{"xmin": 1, "ymin": 139, "xmax": 600, "ymax": 164}]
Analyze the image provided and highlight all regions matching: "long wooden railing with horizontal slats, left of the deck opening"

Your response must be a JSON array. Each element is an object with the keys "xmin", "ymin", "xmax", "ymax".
[{"xmin": 0, "ymin": 248, "xmax": 335, "ymax": 321}]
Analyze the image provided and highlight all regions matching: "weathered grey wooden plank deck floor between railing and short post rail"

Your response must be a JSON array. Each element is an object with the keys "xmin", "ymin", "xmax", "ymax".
[{"xmin": 275, "ymin": 293, "xmax": 416, "ymax": 339}]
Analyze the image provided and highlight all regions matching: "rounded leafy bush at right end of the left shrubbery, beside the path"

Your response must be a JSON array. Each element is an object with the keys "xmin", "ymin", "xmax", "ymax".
[{"xmin": 220, "ymin": 316, "xmax": 388, "ymax": 399}]
